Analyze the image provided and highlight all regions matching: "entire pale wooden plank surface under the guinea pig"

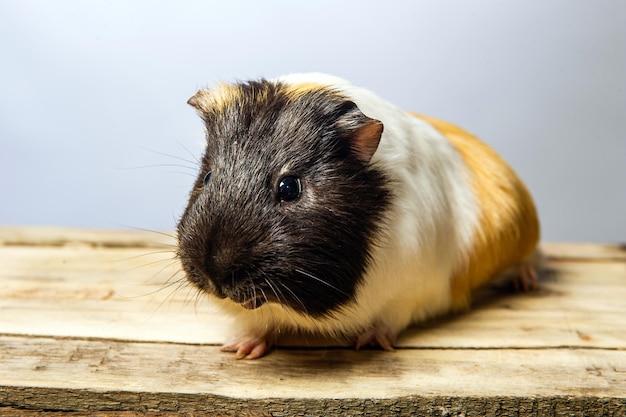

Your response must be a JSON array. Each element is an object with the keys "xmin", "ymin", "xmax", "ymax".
[{"xmin": 0, "ymin": 227, "xmax": 626, "ymax": 416}]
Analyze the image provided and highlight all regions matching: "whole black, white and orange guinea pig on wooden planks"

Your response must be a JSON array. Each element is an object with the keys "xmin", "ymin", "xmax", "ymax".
[{"xmin": 177, "ymin": 74, "xmax": 539, "ymax": 359}]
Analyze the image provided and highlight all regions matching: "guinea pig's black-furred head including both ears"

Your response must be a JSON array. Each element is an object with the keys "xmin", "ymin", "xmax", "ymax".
[{"xmin": 178, "ymin": 80, "xmax": 389, "ymax": 316}]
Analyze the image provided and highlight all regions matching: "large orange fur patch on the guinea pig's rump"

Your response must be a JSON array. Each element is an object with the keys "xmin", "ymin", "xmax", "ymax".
[{"xmin": 410, "ymin": 113, "xmax": 539, "ymax": 310}]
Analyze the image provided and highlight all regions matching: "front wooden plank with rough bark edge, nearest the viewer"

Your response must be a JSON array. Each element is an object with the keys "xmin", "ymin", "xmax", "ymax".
[{"xmin": 0, "ymin": 337, "xmax": 626, "ymax": 415}]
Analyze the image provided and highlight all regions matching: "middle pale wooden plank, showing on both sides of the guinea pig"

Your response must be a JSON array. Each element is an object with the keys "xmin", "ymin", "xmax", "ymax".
[{"xmin": 0, "ymin": 242, "xmax": 626, "ymax": 348}]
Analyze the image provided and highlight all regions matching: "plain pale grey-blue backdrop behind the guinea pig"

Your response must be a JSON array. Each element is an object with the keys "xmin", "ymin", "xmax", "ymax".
[{"xmin": 0, "ymin": 0, "xmax": 626, "ymax": 242}]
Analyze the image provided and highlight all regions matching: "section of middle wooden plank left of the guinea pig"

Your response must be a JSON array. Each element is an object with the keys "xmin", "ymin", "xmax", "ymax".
[{"xmin": 0, "ymin": 242, "xmax": 231, "ymax": 344}]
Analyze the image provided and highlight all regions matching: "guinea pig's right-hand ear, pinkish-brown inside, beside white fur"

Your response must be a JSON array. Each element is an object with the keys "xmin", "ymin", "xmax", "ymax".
[{"xmin": 337, "ymin": 102, "xmax": 384, "ymax": 162}]
